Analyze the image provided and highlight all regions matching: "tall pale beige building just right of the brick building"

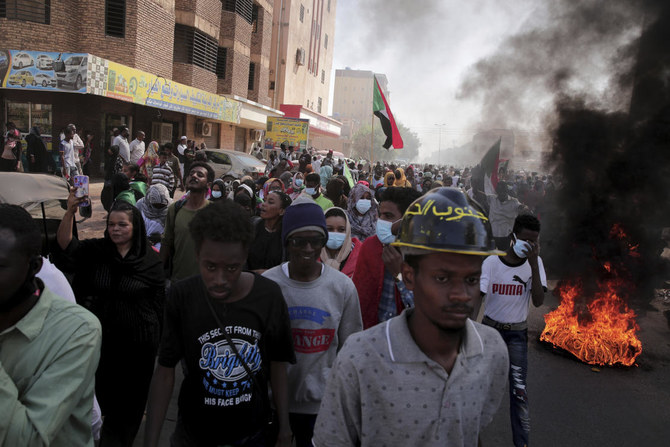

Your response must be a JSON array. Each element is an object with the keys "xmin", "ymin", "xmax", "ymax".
[{"xmin": 269, "ymin": 0, "xmax": 341, "ymax": 149}]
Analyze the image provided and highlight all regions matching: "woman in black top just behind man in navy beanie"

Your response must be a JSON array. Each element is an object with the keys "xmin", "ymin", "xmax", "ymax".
[{"xmin": 247, "ymin": 190, "xmax": 291, "ymax": 273}]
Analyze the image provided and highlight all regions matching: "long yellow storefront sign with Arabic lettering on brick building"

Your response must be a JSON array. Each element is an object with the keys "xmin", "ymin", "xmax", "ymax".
[{"xmin": 89, "ymin": 56, "xmax": 240, "ymax": 124}]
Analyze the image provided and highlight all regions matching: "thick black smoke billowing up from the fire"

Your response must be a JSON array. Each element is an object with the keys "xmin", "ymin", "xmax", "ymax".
[{"xmin": 461, "ymin": 0, "xmax": 670, "ymax": 311}]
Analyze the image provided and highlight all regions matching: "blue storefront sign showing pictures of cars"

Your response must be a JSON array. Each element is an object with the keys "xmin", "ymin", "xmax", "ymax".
[{"xmin": 0, "ymin": 49, "xmax": 88, "ymax": 93}]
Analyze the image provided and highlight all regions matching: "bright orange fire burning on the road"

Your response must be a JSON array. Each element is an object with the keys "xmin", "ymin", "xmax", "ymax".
[{"xmin": 540, "ymin": 225, "xmax": 642, "ymax": 366}]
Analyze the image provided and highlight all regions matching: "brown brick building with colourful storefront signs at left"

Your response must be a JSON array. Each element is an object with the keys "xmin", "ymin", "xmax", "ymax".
[{"xmin": 0, "ymin": 0, "xmax": 284, "ymax": 178}]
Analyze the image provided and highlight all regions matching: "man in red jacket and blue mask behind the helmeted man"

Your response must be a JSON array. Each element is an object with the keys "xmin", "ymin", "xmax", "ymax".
[{"xmin": 352, "ymin": 187, "xmax": 421, "ymax": 329}]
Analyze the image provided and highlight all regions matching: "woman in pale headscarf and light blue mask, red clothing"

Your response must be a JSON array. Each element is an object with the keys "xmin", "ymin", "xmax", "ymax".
[{"xmin": 321, "ymin": 208, "xmax": 363, "ymax": 278}]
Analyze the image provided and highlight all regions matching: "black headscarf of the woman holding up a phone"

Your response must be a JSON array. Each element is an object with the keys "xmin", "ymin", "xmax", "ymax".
[{"xmin": 103, "ymin": 202, "xmax": 165, "ymax": 287}]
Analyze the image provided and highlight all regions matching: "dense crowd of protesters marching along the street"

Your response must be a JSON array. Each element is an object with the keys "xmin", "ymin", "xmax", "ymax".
[{"xmin": 0, "ymin": 126, "xmax": 555, "ymax": 446}]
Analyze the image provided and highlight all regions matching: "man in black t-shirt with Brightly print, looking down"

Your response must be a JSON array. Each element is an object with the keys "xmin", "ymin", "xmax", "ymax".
[{"xmin": 144, "ymin": 202, "xmax": 295, "ymax": 447}]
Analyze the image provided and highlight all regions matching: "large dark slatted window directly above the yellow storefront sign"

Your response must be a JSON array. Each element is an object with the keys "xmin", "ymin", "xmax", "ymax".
[{"xmin": 174, "ymin": 24, "xmax": 218, "ymax": 75}]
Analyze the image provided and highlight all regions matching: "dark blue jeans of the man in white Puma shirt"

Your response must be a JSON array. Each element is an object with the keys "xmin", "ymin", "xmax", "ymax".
[{"xmin": 498, "ymin": 329, "xmax": 530, "ymax": 447}]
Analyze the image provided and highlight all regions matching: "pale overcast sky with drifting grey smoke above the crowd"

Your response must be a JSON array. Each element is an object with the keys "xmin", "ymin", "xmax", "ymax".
[{"xmin": 329, "ymin": 0, "xmax": 639, "ymax": 163}]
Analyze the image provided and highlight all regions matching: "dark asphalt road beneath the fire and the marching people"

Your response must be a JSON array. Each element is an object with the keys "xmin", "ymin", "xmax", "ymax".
[{"xmin": 79, "ymin": 183, "xmax": 670, "ymax": 447}]
